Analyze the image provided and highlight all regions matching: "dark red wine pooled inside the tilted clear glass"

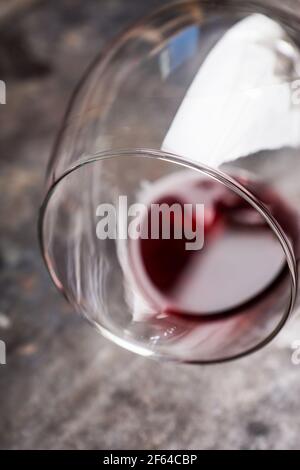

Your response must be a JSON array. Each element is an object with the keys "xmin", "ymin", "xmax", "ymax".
[{"xmin": 130, "ymin": 171, "xmax": 297, "ymax": 316}]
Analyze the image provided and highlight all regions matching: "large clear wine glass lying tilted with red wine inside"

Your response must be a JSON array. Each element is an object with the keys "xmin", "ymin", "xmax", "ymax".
[{"xmin": 39, "ymin": 0, "xmax": 300, "ymax": 364}]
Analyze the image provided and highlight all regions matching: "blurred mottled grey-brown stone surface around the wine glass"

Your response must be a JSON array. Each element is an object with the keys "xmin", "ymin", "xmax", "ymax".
[{"xmin": 0, "ymin": 0, "xmax": 300, "ymax": 449}]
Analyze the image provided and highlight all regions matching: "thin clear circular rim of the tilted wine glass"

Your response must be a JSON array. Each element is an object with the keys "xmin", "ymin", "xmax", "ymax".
[{"xmin": 38, "ymin": 148, "xmax": 298, "ymax": 365}]
